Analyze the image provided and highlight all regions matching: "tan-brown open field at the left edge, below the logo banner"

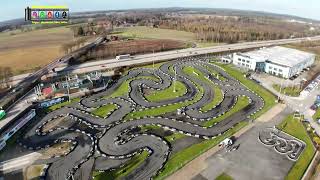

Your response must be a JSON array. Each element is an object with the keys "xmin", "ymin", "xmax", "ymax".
[{"xmin": 0, "ymin": 27, "xmax": 73, "ymax": 74}]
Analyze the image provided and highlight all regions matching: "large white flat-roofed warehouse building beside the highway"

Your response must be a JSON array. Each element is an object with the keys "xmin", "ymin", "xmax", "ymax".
[{"xmin": 233, "ymin": 46, "xmax": 316, "ymax": 78}]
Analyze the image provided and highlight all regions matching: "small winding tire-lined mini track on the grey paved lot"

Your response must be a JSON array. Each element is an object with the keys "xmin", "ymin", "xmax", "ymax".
[{"xmin": 259, "ymin": 127, "xmax": 306, "ymax": 161}]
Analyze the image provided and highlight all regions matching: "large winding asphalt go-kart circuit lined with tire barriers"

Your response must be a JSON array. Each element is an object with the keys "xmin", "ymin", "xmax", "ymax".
[{"xmin": 20, "ymin": 58, "xmax": 264, "ymax": 180}]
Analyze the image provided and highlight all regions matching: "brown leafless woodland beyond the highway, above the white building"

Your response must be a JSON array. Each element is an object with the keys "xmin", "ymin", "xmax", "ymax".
[{"xmin": 157, "ymin": 16, "xmax": 319, "ymax": 43}]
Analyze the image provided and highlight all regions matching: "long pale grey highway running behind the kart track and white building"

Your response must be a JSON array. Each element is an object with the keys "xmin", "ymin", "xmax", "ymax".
[{"xmin": 4, "ymin": 36, "xmax": 320, "ymax": 84}]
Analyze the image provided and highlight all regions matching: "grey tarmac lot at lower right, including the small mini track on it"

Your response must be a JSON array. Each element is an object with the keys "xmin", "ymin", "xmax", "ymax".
[{"xmin": 192, "ymin": 108, "xmax": 305, "ymax": 180}]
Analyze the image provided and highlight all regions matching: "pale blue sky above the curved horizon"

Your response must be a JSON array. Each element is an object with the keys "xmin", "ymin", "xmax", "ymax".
[{"xmin": 0, "ymin": 0, "xmax": 320, "ymax": 21}]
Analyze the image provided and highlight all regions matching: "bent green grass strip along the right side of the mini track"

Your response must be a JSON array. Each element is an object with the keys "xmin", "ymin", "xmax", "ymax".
[{"xmin": 277, "ymin": 115, "xmax": 315, "ymax": 180}]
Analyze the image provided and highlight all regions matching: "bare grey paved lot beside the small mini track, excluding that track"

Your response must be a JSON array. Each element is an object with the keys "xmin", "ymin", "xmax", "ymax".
[{"xmin": 193, "ymin": 109, "xmax": 294, "ymax": 180}]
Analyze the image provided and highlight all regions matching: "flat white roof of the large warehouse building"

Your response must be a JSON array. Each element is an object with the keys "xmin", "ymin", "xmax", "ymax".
[{"xmin": 242, "ymin": 46, "xmax": 315, "ymax": 67}]
